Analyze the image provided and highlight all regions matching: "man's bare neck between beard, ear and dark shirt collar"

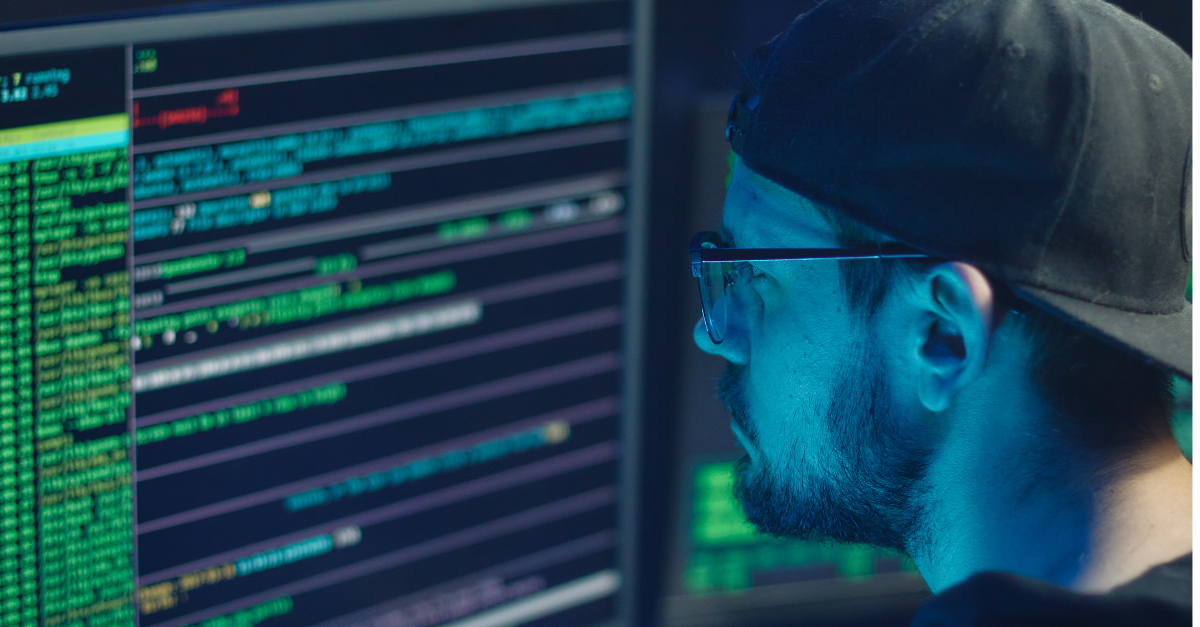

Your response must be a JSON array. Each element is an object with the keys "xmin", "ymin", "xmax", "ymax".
[{"xmin": 911, "ymin": 369, "xmax": 1192, "ymax": 592}]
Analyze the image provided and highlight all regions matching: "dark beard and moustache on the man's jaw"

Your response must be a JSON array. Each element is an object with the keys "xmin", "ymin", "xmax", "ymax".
[{"xmin": 718, "ymin": 350, "xmax": 930, "ymax": 553}]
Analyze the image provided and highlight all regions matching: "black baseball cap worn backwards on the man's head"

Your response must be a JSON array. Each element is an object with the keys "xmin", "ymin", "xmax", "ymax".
[{"xmin": 727, "ymin": 0, "xmax": 1192, "ymax": 380}]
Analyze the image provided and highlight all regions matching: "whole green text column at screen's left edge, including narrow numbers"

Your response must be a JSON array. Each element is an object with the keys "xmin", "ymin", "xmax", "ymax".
[{"xmin": 0, "ymin": 94, "xmax": 133, "ymax": 626}]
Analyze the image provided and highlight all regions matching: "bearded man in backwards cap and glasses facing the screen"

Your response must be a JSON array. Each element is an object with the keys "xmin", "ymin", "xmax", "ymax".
[{"xmin": 692, "ymin": 0, "xmax": 1192, "ymax": 626}]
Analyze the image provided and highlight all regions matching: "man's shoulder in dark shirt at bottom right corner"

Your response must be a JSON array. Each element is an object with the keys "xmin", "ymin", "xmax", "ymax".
[{"xmin": 912, "ymin": 554, "xmax": 1192, "ymax": 627}]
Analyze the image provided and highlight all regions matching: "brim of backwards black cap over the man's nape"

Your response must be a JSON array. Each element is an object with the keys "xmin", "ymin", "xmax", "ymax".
[{"xmin": 1010, "ymin": 283, "xmax": 1192, "ymax": 381}]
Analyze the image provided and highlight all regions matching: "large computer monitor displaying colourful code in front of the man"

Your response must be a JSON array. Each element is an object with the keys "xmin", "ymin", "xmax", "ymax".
[{"xmin": 0, "ymin": 0, "xmax": 644, "ymax": 627}]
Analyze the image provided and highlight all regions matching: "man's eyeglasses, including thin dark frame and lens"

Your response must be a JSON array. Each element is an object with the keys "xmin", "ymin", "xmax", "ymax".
[{"xmin": 690, "ymin": 231, "xmax": 930, "ymax": 344}]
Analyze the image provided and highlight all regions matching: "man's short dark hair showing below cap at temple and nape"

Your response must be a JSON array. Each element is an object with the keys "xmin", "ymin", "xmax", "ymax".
[{"xmin": 743, "ymin": 40, "xmax": 1174, "ymax": 450}]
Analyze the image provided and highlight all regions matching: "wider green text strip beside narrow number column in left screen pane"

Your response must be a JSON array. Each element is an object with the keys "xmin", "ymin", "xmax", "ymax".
[{"xmin": 25, "ymin": 149, "xmax": 133, "ymax": 625}]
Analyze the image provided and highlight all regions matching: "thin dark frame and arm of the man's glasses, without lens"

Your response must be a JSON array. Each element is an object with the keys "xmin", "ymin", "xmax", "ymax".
[{"xmin": 689, "ymin": 231, "xmax": 932, "ymax": 344}]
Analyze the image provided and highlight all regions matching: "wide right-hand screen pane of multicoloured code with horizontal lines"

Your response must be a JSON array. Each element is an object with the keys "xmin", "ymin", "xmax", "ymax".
[{"xmin": 131, "ymin": 4, "xmax": 632, "ymax": 614}]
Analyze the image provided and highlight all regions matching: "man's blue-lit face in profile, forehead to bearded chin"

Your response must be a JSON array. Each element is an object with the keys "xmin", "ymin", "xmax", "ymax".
[{"xmin": 695, "ymin": 160, "xmax": 926, "ymax": 549}]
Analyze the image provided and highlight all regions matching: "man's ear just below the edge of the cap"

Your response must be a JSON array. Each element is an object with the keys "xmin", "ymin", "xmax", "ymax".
[{"xmin": 916, "ymin": 262, "xmax": 995, "ymax": 412}]
